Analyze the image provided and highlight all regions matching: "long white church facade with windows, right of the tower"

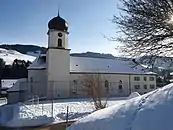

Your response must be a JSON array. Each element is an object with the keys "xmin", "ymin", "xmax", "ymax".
[{"xmin": 70, "ymin": 73, "xmax": 156, "ymax": 97}]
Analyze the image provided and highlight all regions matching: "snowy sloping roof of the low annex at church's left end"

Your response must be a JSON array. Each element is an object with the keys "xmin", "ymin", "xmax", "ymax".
[{"xmin": 7, "ymin": 78, "xmax": 27, "ymax": 92}]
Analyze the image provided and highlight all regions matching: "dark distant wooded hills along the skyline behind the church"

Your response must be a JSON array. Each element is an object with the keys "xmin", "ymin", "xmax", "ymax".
[{"xmin": 0, "ymin": 44, "xmax": 173, "ymax": 70}]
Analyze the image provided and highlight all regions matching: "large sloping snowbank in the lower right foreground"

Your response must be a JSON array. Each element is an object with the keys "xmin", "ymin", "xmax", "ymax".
[{"xmin": 67, "ymin": 83, "xmax": 173, "ymax": 130}]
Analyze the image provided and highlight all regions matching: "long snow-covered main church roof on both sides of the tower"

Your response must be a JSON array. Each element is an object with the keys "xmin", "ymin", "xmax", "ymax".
[{"xmin": 28, "ymin": 55, "xmax": 156, "ymax": 74}]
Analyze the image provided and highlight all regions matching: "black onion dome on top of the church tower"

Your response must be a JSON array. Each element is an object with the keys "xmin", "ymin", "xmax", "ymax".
[{"xmin": 48, "ymin": 14, "xmax": 68, "ymax": 31}]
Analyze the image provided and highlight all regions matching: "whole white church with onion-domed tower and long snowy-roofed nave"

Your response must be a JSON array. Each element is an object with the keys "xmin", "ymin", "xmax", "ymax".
[{"xmin": 8, "ymin": 15, "xmax": 156, "ymax": 102}]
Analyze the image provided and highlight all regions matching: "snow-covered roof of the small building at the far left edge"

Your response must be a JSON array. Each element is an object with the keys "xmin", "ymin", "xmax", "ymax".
[{"xmin": 1, "ymin": 79, "xmax": 17, "ymax": 89}]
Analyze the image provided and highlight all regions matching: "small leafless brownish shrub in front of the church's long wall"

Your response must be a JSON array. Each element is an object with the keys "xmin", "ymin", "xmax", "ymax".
[{"xmin": 81, "ymin": 74, "xmax": 109, "ymax": 110}]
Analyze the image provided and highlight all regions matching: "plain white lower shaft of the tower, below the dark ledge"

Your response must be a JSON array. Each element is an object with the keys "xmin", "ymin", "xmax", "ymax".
[{"xmin": 47, "ymin": 49, "xmax": 70, "ymax": 97}]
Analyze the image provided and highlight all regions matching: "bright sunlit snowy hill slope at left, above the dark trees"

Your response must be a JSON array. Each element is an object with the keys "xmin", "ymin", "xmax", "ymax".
[{"xmin": 0, "ymin": 48, "xmax": 36, "ymax": 65}]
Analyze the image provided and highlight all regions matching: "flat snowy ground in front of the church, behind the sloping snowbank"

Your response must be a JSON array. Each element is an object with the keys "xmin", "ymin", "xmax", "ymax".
[{"xmin": 0, "ymin": 98, "xmax": 126, "ymax": 126}]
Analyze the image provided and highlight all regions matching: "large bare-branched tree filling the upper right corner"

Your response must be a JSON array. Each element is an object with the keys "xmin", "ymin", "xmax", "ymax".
[{"xmin": 112, "ymin": 0, "xmax": 173, "ymax": 64}]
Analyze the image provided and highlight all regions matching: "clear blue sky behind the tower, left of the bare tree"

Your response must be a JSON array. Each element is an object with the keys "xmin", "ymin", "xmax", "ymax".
[{"xmin": 0, "ymin": 0, "xmax": 118, "ymax": 55}]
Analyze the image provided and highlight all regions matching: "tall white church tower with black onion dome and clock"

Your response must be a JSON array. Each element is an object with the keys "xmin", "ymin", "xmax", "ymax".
[{"xmin": 46, "ymin": 13, "xmax": 70, "ymax": 98}]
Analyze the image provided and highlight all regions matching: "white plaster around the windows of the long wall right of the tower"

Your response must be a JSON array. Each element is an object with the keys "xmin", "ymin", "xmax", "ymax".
[{"xmin": 70, "ymin": 73, "xmax": 156, "ymax": 96}]
